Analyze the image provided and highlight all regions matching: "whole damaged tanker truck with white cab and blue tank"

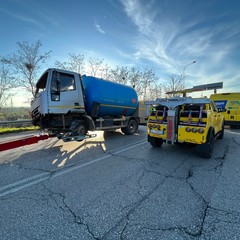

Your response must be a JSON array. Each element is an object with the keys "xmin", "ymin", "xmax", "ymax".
[{"xmin": 31, "ymin": 68, "xmax": 147, "ymax": 141}]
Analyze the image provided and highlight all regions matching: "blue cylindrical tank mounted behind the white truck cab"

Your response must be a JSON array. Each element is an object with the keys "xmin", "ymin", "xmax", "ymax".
[{"xmin": 82, "ymin": 75, "xmax": 138, "ymax": 117}]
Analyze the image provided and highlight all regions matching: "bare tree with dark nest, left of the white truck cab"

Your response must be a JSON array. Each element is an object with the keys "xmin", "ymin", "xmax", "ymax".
[{"xmin": 2, "ymin": 40, "xmax": 51, "ymax": 96}]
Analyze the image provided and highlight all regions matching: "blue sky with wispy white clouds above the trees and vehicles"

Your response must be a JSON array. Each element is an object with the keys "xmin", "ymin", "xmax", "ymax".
[{"xmin": 0, "ymin": 0, "xmax": 240, "ymax": 104}]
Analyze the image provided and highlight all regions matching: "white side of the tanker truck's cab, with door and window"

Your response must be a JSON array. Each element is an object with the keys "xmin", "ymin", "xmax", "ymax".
[{"xmin": 48, "ymin": 70, "xmax": 85, "ymax": 114}]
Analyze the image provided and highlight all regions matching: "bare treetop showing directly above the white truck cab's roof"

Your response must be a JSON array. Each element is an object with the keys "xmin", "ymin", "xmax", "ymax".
[{"xmin": 55, "ymin": 53, "xmax": 85, "ymax": 74}]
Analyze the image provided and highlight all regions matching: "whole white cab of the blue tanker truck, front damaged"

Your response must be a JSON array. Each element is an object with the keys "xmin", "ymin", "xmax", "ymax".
[{"xmin": 31, "ymin": 69, "xmax": 85, "ymax": 122}]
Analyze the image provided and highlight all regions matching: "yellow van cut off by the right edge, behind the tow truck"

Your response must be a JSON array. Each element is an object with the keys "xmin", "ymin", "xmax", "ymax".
[{"xmin": 210, "ymin": 92, "xmax": 240, "ymax": 127}]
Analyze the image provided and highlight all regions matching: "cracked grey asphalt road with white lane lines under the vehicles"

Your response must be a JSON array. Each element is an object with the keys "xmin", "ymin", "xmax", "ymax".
[{"xmin": 0, "ymin": 127, "xmax": 240, "ymax": 240}]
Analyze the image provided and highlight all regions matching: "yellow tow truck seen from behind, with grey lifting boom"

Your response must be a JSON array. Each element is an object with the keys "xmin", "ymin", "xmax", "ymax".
[{"xmin": 145, "ymin": 97, "xmax": 224, "ymax": 158}]
